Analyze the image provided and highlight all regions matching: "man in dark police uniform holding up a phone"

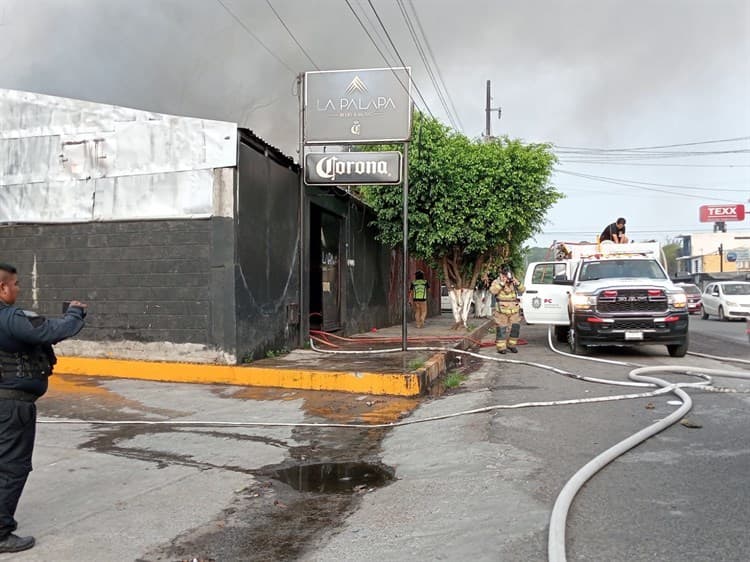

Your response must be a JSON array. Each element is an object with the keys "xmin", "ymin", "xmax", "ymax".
[{"xmin": 0, "ymin": 263, "xmax": 86, "ymax": 553}]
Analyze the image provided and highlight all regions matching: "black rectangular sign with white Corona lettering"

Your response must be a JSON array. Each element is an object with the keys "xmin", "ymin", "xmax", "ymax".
[{"xmin": 305, "ymin": 152, "xmax": 401, "ymax": 185}]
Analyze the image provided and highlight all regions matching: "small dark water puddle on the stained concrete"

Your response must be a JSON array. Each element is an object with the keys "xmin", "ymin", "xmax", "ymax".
[{"xmin": 272, "ymin": 462, "xmax": 393, "ymax": 494}]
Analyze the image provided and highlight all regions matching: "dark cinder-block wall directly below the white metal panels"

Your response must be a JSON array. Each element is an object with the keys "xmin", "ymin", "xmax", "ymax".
[{"xmin": 0, "ymin": 219, "xmax": 226, "ymax": 347}]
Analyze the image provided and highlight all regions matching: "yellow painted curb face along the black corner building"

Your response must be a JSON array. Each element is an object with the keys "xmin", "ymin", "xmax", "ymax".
[{"xmin": 55, "ymin": 357, "xmax": 422, "ymax": 396}]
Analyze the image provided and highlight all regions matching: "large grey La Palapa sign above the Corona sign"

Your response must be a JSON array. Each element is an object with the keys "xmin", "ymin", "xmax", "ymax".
[{"xmin": 304, "ymin": 67, "xmax": 412, "ymax": 144}]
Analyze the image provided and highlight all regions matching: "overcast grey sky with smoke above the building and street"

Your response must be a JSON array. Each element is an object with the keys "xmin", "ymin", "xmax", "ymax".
[{"xmin": 0, "ymin": 0, "xmax": 750, "ymax": 245}]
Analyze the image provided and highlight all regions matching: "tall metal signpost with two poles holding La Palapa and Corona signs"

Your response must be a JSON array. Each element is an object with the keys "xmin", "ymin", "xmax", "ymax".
[{"xmin": 299, "ymin": 67, "xmax": 413, "ymax": 351}]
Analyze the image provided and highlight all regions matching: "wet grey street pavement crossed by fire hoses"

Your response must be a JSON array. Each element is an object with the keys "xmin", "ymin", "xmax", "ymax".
[{"xmin": 0, "ymin": 320, "xmax": 750, "ymax": 562}]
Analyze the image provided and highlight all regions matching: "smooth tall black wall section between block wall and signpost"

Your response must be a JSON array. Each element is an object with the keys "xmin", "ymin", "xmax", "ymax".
[{"xmin": 235, "ymin": 134, "xmax": 300, "ymax": 361}]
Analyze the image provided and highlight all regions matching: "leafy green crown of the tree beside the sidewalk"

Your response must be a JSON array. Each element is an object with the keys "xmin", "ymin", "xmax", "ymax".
[{"xmin": 364, "ymin": 114, "xmax": 562, "ymax": 289}]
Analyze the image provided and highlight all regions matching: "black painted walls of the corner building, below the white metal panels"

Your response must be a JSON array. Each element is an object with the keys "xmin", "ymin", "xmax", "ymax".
[{"xmin": 0, "ymin": 130, "xmax": 432, "ymax": 362}]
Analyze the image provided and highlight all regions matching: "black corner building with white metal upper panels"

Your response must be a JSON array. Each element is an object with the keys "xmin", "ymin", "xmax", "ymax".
[{"xmin": 0, "ymin": 86, "xmax": 440, "ymax": 364}]
